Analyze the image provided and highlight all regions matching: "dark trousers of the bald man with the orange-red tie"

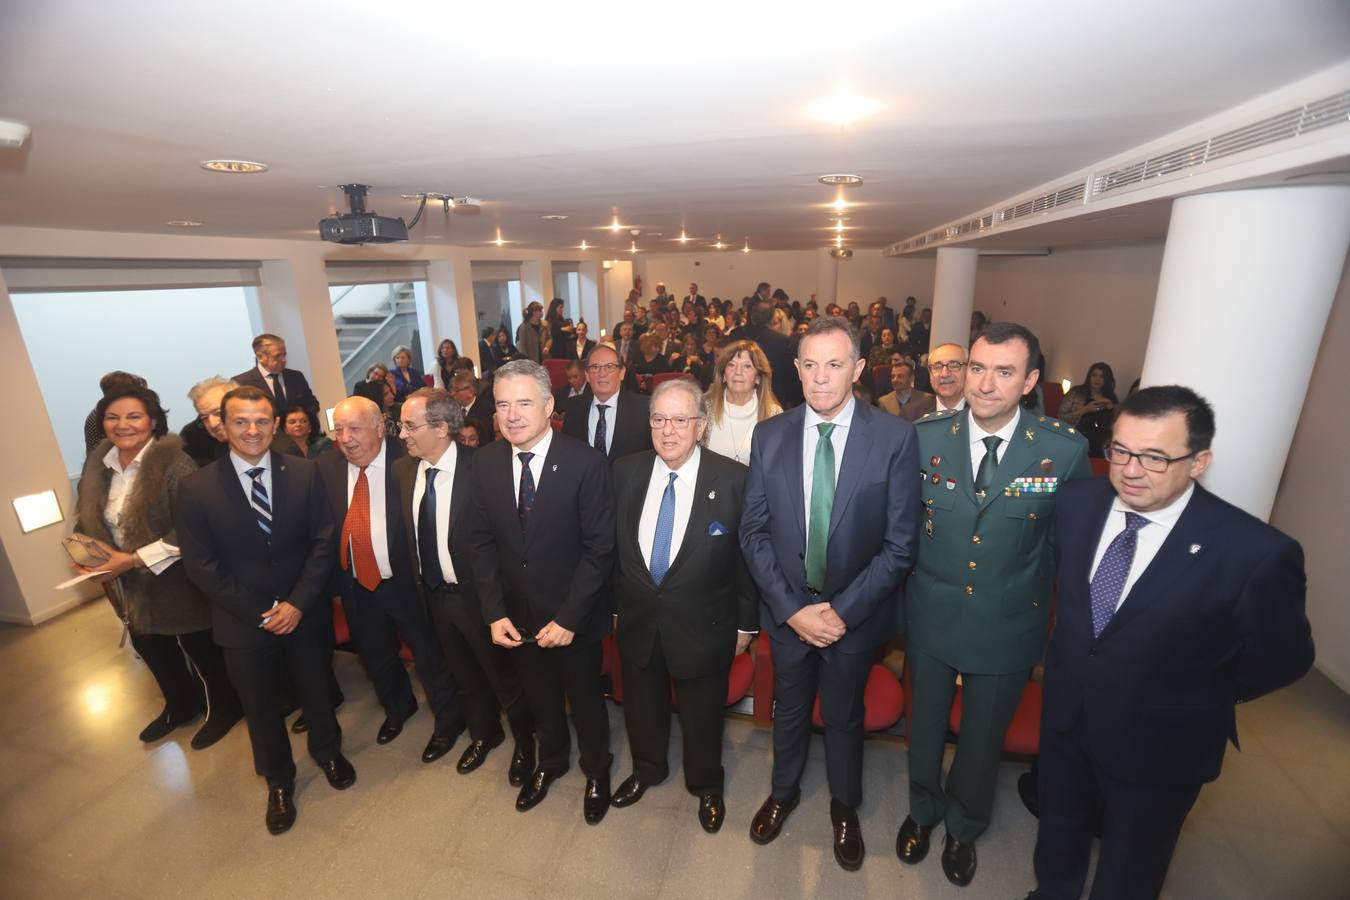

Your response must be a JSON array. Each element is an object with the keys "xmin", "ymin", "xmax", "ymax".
[{"xmin": 339, "ymin": 572, "xmax": 464, "ymax": 737}]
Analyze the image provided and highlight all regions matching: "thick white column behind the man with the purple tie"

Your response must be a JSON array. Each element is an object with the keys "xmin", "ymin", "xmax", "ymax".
[{"xmin": 1141, "ymin": 185, "xmax": 1350, "ymax": 519}]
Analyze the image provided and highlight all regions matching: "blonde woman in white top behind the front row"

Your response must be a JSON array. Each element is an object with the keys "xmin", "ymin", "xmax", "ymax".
[{"xmin": 703, "ymin": 340, "xmax": 783, "ymax": 464}]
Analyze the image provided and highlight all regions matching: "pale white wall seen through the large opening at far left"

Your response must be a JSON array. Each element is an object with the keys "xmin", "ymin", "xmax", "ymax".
[{"xmin": 11, "ymin": 287, "xmax": 254, "ymax": 476}]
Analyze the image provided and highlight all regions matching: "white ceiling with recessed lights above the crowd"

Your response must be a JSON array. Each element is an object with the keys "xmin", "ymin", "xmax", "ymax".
[{"xmin": 0, "ymin": 0, "xmax": 1350, "ymax": 251}]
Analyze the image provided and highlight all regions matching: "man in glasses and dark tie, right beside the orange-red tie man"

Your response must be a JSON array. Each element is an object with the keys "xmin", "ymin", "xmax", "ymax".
[{"xmin": 394, "ymin": 387, "xmax": 535, "ymax": 787}]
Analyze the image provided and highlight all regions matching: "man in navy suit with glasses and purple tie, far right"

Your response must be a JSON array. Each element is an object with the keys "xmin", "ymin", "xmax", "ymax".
[{"xmin": 1031, "ymin": 386, "xmax": 1314, "ymax": 899}]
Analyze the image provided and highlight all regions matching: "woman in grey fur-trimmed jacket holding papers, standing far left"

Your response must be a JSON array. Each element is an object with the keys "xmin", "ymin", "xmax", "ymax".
[{"xmin": 76, "ymin": 385, "xmax": 243, "ymax": 750}]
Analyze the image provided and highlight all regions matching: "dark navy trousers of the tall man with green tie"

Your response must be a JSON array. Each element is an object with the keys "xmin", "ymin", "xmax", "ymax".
[{"xmin": 772, "ymin": 646, "xmax": 872, "ymax": 810}]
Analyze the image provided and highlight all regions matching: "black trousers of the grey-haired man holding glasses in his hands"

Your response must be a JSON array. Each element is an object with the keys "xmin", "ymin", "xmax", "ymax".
[{"xmin": 509, "ymin": 638, "xmax": 614, "ymax": 779}]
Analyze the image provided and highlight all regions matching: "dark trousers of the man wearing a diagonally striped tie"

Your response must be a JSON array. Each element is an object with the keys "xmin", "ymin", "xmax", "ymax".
[{"xmin": 224, "ymin": 625, "xmax": 342, "ymax": 788}]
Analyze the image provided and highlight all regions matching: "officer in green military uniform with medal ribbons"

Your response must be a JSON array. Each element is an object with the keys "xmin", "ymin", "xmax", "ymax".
[{"xmin": 895, "ymin": 322, "xmax": 1091, "ymax": 887}]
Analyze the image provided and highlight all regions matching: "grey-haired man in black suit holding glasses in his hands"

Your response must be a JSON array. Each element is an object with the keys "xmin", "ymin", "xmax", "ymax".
[{"xmin": 470, "ymin": 360, "xmax": 614, "ymax": 824}]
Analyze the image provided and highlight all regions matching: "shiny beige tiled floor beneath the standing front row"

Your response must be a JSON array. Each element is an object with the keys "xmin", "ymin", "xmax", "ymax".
[{"xmin": 0, "ymin": 604, "xmax": 1350, "ymax": 900}]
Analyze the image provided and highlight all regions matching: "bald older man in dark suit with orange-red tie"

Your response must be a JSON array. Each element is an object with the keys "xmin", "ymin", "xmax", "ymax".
[{"xmin": 319, "ymin": 397, "xmax": 464, "ymax": 762}]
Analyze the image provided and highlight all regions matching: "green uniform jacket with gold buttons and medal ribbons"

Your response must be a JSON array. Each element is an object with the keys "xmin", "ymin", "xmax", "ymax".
[{"xmin": 906, "ymin": 409, "xmax": 1092, "ymax": 675}]
